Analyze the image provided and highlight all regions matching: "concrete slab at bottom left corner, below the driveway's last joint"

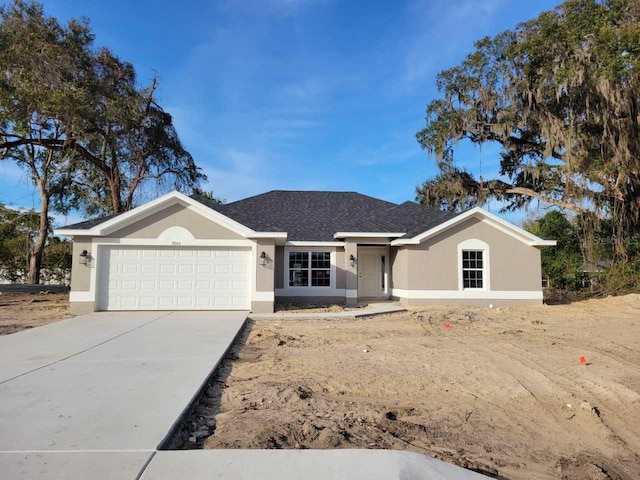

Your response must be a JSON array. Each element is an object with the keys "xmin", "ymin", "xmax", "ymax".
[{"xmin": 0, "ymin": 452, "xmax": 153, "ymax": 480}]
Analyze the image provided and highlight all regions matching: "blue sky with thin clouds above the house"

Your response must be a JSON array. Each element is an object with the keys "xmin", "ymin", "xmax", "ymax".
[{"xmin": 0, "ymin": 0, "xmax": 559, "ymax": 224}]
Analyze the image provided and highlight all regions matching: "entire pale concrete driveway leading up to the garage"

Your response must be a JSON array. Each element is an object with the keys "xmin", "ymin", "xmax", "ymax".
[{"xmin": 0, "ymin": 312, "xmax": 246, "ymax": 479}]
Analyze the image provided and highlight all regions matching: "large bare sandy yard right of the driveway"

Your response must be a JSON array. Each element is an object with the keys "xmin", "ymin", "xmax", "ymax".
[{"xmin": 173, "ymin": 295, "xmax": 640, "ymax": 480}]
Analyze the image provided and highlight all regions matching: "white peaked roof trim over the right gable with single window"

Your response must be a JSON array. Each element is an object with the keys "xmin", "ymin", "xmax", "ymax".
[{"xmin": 391, "ymin": 207, "xmax": 556, "ymax": 247}]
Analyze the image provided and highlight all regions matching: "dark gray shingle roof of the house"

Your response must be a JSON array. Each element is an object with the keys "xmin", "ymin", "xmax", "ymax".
[{"xmin": 64, "ymin": 190, "xmax": 456, "ymax": 241}]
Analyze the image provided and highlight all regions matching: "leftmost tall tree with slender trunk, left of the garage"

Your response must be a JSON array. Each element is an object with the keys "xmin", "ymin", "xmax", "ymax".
[{"xmin": 0, "ymin": 0, "xmax": 92, "ymax": 283}]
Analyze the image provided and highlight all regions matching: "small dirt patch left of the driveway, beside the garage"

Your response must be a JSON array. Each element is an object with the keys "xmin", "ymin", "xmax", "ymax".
[{"xmin": 0, "ymin": 292, "xmax": 69, "ymax": 335}]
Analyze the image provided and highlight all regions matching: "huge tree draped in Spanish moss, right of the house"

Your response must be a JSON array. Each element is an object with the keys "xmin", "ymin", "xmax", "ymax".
[{"xmin": 417, "ymin": 0, "xmax": 640, "ymax": 258}]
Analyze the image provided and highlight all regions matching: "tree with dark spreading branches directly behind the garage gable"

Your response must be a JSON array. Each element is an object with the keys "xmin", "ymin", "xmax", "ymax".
[{"xmin": 66, "ymin": 49, "xmax": 206, "ymax": 215}]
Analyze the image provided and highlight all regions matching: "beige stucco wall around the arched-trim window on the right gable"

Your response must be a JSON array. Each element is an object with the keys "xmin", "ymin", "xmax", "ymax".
[{"xmin": 393, "ymin": 218, "xmax": 541, "ymax": 291}]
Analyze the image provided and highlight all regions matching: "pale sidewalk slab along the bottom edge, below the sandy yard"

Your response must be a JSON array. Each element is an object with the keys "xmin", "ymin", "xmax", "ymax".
[{"xmin": 141, "ymin": 450, "xmax": 488, "ymax": 480}]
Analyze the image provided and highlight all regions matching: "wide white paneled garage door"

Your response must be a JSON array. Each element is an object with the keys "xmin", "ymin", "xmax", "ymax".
[{"xmin": 98, "ymin": 247, "xmax": 251, "ymax": 310}]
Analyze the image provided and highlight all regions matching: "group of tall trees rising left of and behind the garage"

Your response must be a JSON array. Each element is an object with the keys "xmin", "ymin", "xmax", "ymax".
[{"xmin": 0, "ymin": 0, "xmax": 206, "ymax": 283}]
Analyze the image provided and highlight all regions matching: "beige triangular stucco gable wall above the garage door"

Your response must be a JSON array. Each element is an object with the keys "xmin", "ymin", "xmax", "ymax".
[{"xmin": 109, "ymin": 204, "xmax": 243, "ymax": 240}]
